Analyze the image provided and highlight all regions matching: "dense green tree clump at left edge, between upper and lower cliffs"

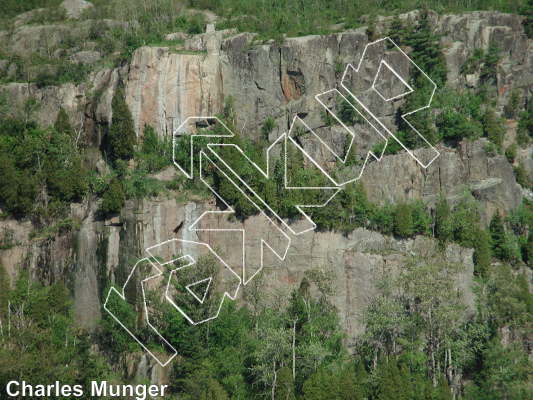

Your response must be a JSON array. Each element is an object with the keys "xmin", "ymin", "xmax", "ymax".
[{"xmin": 0, "ymin": 114, "xmax": 87, "ymax": 218}]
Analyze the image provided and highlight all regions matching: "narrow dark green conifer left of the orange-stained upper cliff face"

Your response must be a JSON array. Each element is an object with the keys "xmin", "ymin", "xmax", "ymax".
[{"xmin": 108, "ymin": 85, "xmax": 136, "ymax": 161}]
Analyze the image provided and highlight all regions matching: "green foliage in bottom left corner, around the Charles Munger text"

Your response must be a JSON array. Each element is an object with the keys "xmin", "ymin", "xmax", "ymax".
[{"xmin": 0, "ymin": 272, "xmax": 109, "ymax": 387}]
